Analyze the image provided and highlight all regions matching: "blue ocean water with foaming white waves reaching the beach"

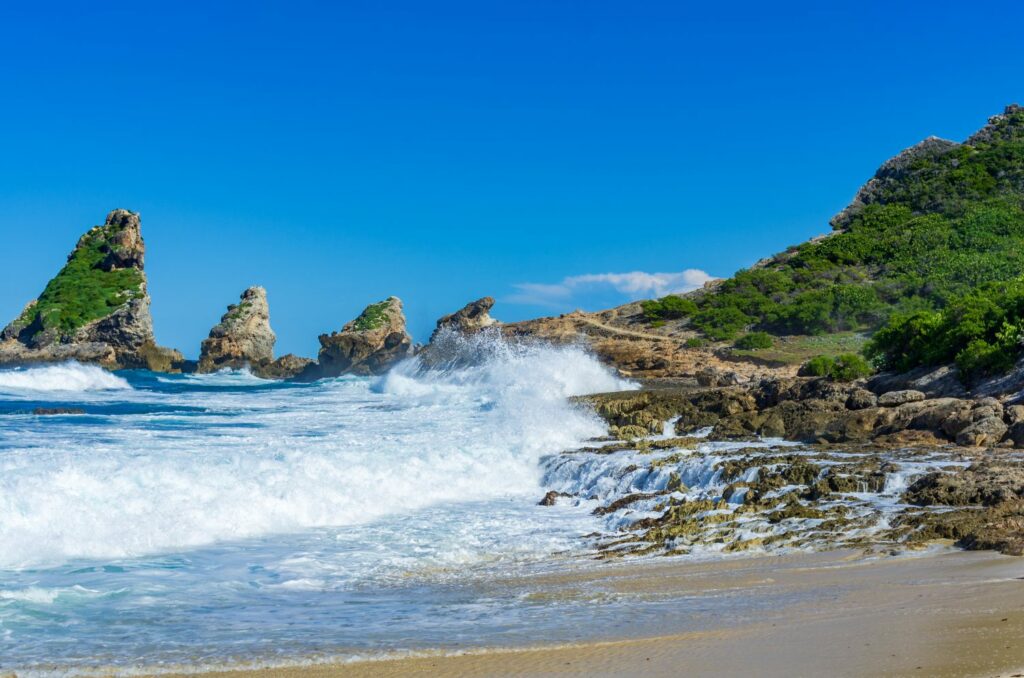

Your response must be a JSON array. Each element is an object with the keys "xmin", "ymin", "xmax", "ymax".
[{"xmin": 0, "ymin": 337, "xmax": 647, "ymax": 674}]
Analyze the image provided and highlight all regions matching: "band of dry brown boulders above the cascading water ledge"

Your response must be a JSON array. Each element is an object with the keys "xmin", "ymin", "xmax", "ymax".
[{"xmin": 581, "ymin": 378, "xmax": 1024, "ymax": 448}]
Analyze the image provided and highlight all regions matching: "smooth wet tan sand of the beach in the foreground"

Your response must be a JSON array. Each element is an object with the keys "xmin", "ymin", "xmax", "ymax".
[{"xmin": 153, "ymin": 551, "xmax": 1024, "ymax": 678}]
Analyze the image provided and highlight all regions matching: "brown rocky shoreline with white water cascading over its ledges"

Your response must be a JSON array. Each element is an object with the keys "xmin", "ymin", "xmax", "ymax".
[{"xmin": 542, "ymin": 378, "xmax": 1024, "ymax": 556}]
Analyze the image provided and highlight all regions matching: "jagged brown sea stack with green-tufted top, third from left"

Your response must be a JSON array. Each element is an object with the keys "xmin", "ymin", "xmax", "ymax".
[{"xmin": 297, "ymin": 297, "xmax": 413, "ymax": 381}]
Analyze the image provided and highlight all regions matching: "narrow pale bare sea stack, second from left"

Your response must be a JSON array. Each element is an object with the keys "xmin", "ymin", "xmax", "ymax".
[{"xmin": 199, "ymin": 287, "xmax": 278, "ymax": 372}]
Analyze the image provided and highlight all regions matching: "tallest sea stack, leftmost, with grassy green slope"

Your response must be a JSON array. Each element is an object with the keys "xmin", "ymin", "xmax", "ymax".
[{"xmin": 0, "ymin": 209, "xmax": 184, "ymax": 372}]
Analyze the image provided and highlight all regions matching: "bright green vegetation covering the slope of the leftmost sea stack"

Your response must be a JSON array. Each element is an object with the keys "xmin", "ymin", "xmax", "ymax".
[{"xmin": 16, "ymin": 226, "xmax": 144, "ymax": 337}]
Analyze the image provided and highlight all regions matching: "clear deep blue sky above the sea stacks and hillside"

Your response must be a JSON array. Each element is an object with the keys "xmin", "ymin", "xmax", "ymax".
[{"xmin": 0, "ymin": 0, "xmax": 1024, "ymax": 355}]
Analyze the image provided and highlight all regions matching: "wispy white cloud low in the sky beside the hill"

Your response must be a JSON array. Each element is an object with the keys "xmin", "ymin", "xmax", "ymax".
[{"xmin": 504, "ymin": 268, "xmax": 715, "ymax": 307}]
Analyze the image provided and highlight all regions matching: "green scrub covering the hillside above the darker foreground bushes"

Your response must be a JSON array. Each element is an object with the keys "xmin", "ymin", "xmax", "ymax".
[{"xmin": 643, "ymin": 107, "xmax": 1024, "ymax": 350}]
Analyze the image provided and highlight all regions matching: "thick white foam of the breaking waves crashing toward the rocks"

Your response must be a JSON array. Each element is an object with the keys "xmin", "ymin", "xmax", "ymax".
[{"xmin": 0, "ymin": 337, "xmax": 629, "ymax": 568}]
